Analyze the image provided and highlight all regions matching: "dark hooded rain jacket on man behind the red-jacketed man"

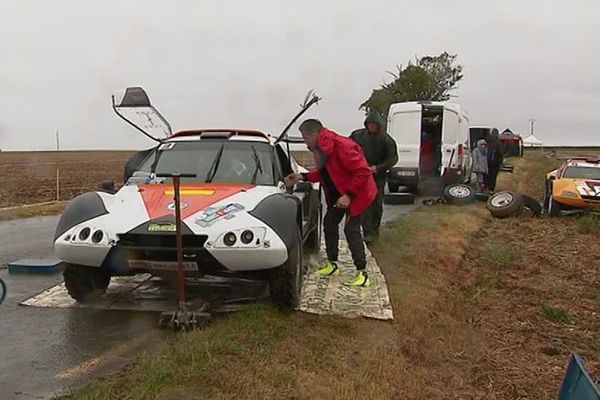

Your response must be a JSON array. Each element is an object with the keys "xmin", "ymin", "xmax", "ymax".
[{"xmin": 350, "ymin": 111, "xmax": 398, "ymax": 185}]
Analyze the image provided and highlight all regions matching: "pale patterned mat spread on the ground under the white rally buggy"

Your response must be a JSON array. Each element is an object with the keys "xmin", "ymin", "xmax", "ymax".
[{"xmin": 21, "ymin": 240, "xmax": 393, "ymax": 320}]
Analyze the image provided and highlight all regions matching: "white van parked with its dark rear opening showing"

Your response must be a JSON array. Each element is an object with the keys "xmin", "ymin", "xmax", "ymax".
[{"xmin": 387, "ymin": 101, "xmax": 471, "ymax": 193}]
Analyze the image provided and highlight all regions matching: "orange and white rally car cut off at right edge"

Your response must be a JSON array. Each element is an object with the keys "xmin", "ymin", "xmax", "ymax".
[{"xmin": 544, "ymin": 157, "xmax": 600, "ymax": 217}]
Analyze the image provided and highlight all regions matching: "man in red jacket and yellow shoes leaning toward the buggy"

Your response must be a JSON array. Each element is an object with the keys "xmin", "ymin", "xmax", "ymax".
[{"xmin": 286, "ymin": 119, "xmax": 377, "ymax": 286}]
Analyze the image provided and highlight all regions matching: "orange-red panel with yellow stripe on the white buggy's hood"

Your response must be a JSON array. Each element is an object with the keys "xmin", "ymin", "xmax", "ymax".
[{"xmin": 138, "ymin": 184, "xmax": 255, "ymax": 220}]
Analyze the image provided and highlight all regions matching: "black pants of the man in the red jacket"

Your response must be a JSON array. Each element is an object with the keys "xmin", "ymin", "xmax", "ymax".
[{"xmin": 323, "ymin": 206, "xmax": 367, "ymax": 270}]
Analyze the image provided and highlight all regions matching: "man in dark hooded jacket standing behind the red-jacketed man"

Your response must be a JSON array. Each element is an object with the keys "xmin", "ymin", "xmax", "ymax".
[{"xmin": 350, "ymin": 110, "xmax": 398, "ymax": 243}]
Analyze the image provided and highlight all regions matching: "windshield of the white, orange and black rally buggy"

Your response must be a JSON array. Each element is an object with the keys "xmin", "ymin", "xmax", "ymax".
[{"xmin": 138, "ymin": 140, "xmax": 275, "ymax": 185}]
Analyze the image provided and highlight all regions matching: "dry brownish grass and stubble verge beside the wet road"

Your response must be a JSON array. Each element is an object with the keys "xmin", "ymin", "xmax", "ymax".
[{"xmin": 65, "ymin": 149, "xmax": 600, "ymax": 400}]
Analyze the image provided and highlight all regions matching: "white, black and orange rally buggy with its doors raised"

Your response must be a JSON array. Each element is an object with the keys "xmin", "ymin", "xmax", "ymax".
[{"xmin": 54, "ymin": 88, "xmax": 321, "ymax": 307}]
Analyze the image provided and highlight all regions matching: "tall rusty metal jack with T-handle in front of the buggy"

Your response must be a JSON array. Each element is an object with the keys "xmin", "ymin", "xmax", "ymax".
[{"xmin": 157, "ymin": 173, "xmax": 211, "ymax": 332}]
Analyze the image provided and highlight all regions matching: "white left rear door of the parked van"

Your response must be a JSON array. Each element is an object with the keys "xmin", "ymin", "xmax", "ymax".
[{"xmin": 387, "ymin": 102, "xmax": 423, "ymax": 168}]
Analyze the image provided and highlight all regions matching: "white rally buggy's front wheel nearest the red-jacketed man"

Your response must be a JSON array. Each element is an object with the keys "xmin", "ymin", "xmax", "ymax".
[{"xmin": 269, "ymin": 230, "xmax": 303, "ymax": 308}]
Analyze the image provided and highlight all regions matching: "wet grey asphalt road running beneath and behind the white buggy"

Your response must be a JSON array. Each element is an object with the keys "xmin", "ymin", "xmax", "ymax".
[{"xmin": 0, "ymin": 205, "xmax": 415, "ymax": 400}]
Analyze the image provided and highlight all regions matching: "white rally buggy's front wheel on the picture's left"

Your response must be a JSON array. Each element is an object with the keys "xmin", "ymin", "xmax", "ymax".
[{"xmin": 63, "ymin": 264, "xmax": 110, "ymax": 303}]
